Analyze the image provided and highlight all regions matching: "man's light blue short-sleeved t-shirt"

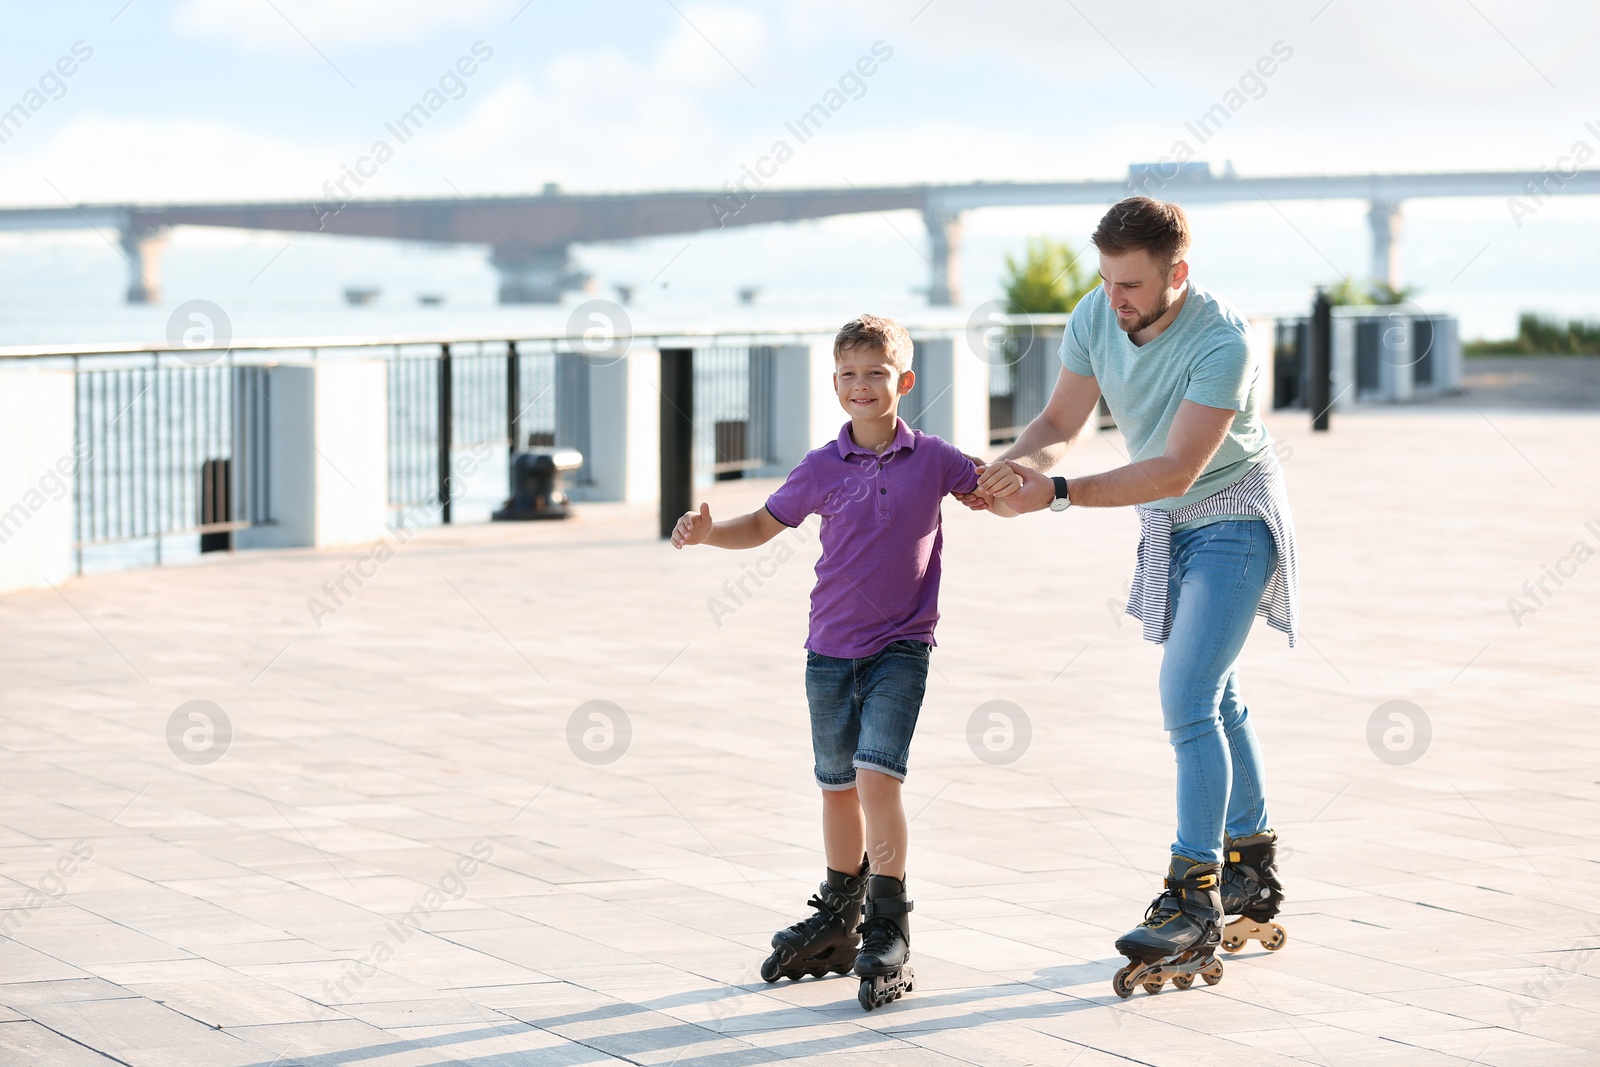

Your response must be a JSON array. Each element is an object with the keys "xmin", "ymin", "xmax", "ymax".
[{"xmin": 1061, "ymin": 282, "xmax": 1272, "ymax": 526}]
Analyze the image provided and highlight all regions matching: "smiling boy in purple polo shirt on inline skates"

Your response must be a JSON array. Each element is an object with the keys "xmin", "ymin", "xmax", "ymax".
[{"xmin": 672, "ymin": 315, "xmax": 978, "ymax": 1011}]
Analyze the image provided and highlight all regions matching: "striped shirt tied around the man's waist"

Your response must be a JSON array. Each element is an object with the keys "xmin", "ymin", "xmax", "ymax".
[{"xmin": 1128, "ymin": 453, "xmax": 1299, "ymax": 648}]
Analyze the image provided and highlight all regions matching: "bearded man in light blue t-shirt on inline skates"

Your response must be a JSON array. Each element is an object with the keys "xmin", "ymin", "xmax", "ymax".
[{"xmin": 962, "ymin": 197, "xmax": 1296, "ymax": 997}]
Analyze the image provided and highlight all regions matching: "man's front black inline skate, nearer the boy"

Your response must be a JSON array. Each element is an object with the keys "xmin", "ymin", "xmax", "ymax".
[{"xmin": 1110, "ymin": 856, "xmax": 1222, "ymax": 998}]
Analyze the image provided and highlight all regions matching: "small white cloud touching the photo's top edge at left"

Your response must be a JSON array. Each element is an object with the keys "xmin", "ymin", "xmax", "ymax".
[{"xmin": 173, "ymin": 0, "xmax": 515, "ymax": 56}]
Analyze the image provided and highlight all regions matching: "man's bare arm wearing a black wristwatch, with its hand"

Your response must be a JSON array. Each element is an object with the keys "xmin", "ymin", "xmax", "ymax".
[{"xmin": 990, "ymin": 400, "xmax": 1238, "ymax": 512}]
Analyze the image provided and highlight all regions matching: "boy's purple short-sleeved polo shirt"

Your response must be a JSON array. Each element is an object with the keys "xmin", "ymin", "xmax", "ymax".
[{"xmin": 766, "ymin": 419, "xmax": 978, "ymax": 659}]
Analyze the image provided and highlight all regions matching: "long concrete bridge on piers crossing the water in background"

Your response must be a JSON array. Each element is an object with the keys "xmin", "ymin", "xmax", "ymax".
[{"xmin": 0, "ymin": 163, "xmax": 1600, "ymax": 307}]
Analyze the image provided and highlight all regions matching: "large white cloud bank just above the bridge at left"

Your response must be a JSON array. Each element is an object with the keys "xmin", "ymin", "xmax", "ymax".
[{"xmin": 0, "ymin": 10, "xmax": 765, "ymax": 205}]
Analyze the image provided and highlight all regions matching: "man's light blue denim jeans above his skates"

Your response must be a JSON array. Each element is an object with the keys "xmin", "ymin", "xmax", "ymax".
[{"xmin": 1162, "ymin": 520, "xmax": 1275, "ymax": 862}]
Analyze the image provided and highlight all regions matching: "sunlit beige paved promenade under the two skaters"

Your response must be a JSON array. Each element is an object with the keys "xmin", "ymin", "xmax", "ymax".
[{"xmin": 0, "ymin": 406, "xmax": 1600, "ymax": 1067}]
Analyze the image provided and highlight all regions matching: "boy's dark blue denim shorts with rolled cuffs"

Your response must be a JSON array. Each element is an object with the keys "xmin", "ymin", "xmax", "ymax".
[{"xmin": 805, "ymin": 640, "xmax": 930, "ymax": 790}]
